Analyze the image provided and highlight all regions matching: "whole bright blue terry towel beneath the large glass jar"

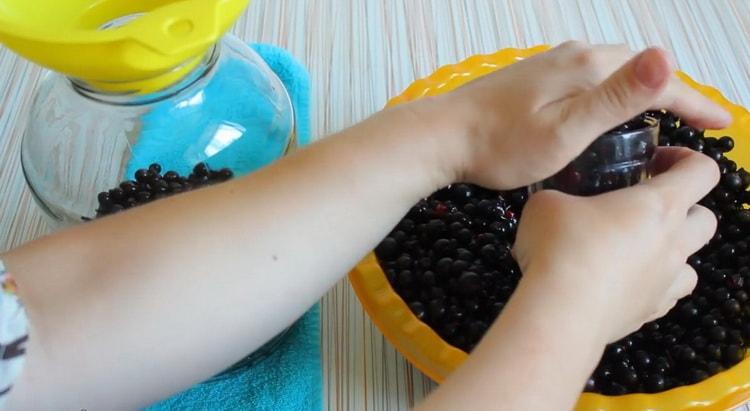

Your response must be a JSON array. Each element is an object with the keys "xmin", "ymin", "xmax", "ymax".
[{"xmin": 135, "ymin": 44, "xmax": 322, "ymax": 411}]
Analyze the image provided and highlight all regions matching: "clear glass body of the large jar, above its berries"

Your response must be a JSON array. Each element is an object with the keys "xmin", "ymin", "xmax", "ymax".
[{"xmin": 21, "ymin": 35, "xmax": 296, "ymax": 229}]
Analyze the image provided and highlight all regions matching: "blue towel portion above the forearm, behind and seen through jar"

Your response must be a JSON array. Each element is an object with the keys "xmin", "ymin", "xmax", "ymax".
[{"xmin": 126, "ymin": 44, "xmax": 310, "ymax": 176}]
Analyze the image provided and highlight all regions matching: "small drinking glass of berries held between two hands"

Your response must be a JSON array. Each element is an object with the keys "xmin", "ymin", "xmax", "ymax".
[{"xmin": 530, "ymin": 117, "xmax": 659, "ymax": 196}]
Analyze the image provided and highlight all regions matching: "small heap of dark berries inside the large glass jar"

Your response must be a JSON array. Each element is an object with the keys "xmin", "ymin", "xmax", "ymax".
[{"xmin": 96, "ymin": 163, "xmax": 234, "ymax": 218}]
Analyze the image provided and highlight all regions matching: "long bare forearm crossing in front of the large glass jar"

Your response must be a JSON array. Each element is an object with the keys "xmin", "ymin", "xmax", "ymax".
[{"xmin": 4, "ymin": 96, "xmax": 468, "ymax": 408}]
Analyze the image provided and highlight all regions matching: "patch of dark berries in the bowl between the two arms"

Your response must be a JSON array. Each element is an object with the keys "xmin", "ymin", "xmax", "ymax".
[{"xmin": 375, "ymin": 184, "xmax": 527, "ymax": 351}]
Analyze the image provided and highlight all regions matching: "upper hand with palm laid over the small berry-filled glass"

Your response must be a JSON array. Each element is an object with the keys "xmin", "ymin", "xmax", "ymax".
[{"xmin": 433, "ymin": 42, "xmax": 731, "ymax": 189}]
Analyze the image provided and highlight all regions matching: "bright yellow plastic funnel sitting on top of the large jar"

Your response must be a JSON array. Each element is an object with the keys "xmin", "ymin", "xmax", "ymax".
[{"xmin": 0, "ymin": 0, "xmax": 249, "ymax": 92}]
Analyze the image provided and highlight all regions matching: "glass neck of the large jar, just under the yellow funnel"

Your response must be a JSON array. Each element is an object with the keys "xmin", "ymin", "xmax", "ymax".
[{"xmin": 68, "ymin": 43, "xmax": 221, "ymax": 106}]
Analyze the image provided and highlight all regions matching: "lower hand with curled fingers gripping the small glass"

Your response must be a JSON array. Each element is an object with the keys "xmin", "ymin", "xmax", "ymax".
[{"xmin": 513, "ymin": 148, "xmax": 719, "ymax": 342}]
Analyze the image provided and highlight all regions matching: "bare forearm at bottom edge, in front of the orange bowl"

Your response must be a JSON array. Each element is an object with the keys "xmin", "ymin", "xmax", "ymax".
[{"xmin": 420, "ymin": 274, "xmax": 606, "ymax": 410}]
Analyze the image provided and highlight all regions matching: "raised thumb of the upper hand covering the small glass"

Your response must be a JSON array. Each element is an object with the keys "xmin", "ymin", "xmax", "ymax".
[{"xmin": 562, "ymin": 48, "xmax": 673, "ymax": 136}]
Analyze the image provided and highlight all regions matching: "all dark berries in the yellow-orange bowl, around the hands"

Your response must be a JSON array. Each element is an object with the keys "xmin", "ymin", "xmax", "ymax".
[{"xmin": 375, "ymin": 111, "xmax": 750, "ymax": 395}]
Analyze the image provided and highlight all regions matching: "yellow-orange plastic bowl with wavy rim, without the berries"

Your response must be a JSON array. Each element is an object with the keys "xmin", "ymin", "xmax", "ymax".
[{"xmin": 349, "ymin": 46, "xmax": 750, "ymax": 410}]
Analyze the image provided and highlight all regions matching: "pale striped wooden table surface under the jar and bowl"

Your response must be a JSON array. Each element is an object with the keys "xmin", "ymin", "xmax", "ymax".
[{"xmin": 0, "ymin": 0, "xmax": 750, "ymax": 410}]
